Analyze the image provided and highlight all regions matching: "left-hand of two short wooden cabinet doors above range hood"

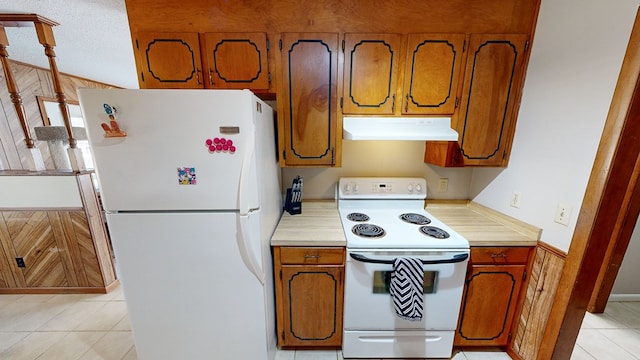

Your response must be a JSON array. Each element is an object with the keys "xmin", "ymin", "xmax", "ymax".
[{"xmin": 342, "ymin": 34, "xmax": 402, "ymax": 115}]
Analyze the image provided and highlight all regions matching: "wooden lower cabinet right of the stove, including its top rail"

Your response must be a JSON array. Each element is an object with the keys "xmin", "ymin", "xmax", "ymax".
[{"xmin": 454, "ymin": 247, "xmax": 533, "ymax": 347}]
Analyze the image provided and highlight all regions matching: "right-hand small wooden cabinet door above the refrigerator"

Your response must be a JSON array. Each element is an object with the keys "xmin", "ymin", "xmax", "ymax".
[{"xmin": 203, "ymin": 33, "xmax": 269, "ymax": 90}]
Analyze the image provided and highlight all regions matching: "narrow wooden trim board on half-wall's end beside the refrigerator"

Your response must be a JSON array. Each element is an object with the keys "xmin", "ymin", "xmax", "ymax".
[{"xmin": 76, "ymin": 174, "xmax": 116, "ymax": 286}]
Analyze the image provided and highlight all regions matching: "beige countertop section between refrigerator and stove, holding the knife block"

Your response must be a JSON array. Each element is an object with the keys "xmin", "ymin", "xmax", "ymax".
[{"xmin": 271, "ymin": 201, "xmax": 347, "ymax": 246}]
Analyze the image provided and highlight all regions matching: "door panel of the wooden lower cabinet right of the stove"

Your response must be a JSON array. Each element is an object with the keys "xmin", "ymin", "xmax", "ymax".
[{"xmin": 455, "ymin": 265, "xmax": 525, "ymax": 346}]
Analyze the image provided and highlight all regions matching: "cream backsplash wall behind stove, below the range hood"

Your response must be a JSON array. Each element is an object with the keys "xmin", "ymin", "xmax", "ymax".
[{"xmin": 282, "ymin": 140, "xmax": 473, "ymax": 199}]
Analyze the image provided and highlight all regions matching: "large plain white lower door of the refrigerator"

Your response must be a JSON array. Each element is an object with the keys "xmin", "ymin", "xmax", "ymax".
[{"xmin": 107, "ymin": 213, "xmax": 275, "ymax": 360}]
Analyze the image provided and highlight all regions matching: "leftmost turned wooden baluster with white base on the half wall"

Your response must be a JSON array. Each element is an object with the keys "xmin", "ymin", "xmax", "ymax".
[{"xmin": 0, "ymin": 26, "xmax": 45, "ymax": 170}]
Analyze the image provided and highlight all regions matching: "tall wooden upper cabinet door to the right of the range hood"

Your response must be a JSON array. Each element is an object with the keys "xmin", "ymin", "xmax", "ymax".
[{"xmin": 457, "ymin": 34, "xmax": 528, "ymax": 166}]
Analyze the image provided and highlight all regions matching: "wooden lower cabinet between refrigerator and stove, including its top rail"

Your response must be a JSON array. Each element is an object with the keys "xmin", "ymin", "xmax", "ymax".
[{"xmin": 274, "ymin": 247, "xmax": 345, "ymax": 348}]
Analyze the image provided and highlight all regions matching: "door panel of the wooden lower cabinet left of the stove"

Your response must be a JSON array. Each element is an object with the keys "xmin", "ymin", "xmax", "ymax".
[{"xmin": 282, "ymin": 266, "xmax": 343, "ymax": 346}]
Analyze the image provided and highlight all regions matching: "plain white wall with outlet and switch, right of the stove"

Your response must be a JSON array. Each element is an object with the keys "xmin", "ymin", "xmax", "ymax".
[{"xmin": 470, "ymin": 0, "xmax": 638, "ymax": 251}]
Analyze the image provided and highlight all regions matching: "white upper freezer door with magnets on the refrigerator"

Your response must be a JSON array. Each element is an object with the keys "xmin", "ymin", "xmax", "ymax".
[{"xmin": 78, "ymin": 89, "xmax": 260, "ymax": 213}]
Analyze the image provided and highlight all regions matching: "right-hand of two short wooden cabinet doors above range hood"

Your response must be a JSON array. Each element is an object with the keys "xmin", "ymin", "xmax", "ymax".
[{"xmin": 402, "ymin": 34, "xmax": 465, "ymax": 115}]
